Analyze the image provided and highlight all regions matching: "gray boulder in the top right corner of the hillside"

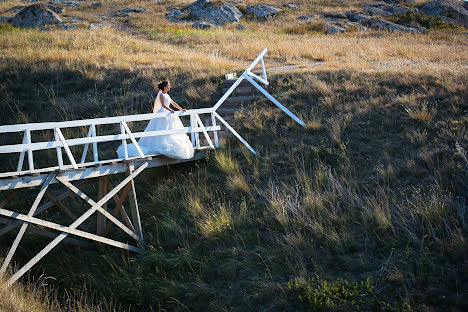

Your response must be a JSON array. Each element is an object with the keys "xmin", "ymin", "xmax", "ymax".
[{"xmin": 421, "ymin": 0, "xmax": 468, "ymax": 27}]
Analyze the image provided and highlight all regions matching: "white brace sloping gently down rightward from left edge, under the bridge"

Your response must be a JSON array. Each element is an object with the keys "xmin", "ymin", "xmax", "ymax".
[{"xmin": 0, "ymin": 209, "xmax": 143, "ymax": 253}]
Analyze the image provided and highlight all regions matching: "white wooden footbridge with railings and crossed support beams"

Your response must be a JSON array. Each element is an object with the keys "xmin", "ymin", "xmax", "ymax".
[{"xmin": 0, "ymin": 49, "xmax": 304, "ymax": 285}]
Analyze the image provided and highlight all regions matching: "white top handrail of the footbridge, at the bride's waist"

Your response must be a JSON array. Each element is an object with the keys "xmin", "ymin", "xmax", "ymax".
[{"xmin": 0, "ymin": 107, "xmax": 214, "ymax": 133}]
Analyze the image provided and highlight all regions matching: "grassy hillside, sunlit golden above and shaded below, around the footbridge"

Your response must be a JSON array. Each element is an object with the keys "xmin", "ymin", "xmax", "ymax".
[{"xmin": 0, "ymin": 0, "xmax": 468, "ymax": 311}]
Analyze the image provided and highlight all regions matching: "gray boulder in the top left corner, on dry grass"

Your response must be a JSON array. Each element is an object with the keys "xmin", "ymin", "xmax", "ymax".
[{"xmin": 11, "ymin": 4, "xmax": 62, "ymax": 28}]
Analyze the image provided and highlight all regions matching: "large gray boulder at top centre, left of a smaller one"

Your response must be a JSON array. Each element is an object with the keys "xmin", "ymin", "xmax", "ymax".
[{"xmin": 183, "ymin": 0, "xmax": 243, "ymax": 26}]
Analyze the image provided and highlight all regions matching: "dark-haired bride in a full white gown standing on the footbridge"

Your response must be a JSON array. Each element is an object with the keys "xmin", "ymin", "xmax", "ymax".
[{"xmin": 117, "ymin": 80, "xmax": 194, "ymax": 159}]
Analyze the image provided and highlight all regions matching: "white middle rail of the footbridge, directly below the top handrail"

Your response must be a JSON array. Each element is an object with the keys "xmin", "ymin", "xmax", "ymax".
[{"xmin": 0, "ymin": 127, "xmax": 220, "ymax": 154}]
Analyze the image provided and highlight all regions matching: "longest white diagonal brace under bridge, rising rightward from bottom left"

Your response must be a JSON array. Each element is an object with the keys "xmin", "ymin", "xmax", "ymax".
[{"xmin": 5, "ymin": 162, "xmax": 148, "ymax": 286}]
